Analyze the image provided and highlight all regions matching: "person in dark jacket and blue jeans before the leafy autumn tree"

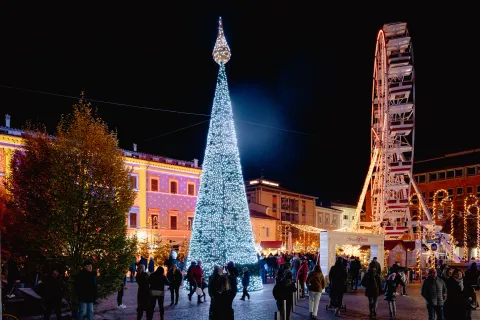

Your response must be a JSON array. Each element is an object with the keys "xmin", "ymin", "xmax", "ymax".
[{"xmin": 75, "ymin": 259, "xmax": 97, "ymax": 320}]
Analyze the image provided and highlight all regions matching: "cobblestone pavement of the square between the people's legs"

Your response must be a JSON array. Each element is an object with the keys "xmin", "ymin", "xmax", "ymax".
[{"xmin": 19, "ymin": 282, "xmax": 480, "ymax": 320}]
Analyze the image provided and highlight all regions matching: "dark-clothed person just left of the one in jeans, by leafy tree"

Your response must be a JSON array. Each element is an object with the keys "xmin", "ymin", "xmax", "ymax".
[{"xmin": 43, "ymin": 269, "xmax": 63, "ymax": 320}]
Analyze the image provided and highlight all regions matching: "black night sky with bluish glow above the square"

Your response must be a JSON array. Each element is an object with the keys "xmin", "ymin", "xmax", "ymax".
[{"xmin": 0, "ymin": 1, "xmax": 480, "ymax": 204}]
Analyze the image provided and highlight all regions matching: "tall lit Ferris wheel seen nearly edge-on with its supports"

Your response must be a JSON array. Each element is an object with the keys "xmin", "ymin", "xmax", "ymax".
[{"xmin": 352, "ymin": 22, "xmax": 431, "ymax": 234}]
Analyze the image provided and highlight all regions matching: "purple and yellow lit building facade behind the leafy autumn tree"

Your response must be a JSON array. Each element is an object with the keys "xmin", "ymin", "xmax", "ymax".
[{"xmin": 0, "ymin": 122, "xmax": 201, "ymax": 248}]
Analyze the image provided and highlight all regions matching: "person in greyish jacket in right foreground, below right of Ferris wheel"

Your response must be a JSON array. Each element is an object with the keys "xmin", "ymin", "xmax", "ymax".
[{"xmin": 421, "ymin": 268, "xmax": 447, "ymax": 320}]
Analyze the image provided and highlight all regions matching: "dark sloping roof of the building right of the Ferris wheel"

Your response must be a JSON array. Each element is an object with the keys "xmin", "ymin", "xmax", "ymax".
[{"xmin": 413, "ymin": 149, "xmax": 480, "ymax": 174}]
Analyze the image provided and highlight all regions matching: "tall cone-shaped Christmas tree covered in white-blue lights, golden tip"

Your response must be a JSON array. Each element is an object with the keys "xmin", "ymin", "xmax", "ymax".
[{"xmin": 187, "ymin": 18, "xmax": 262, "ymax": 290}]
